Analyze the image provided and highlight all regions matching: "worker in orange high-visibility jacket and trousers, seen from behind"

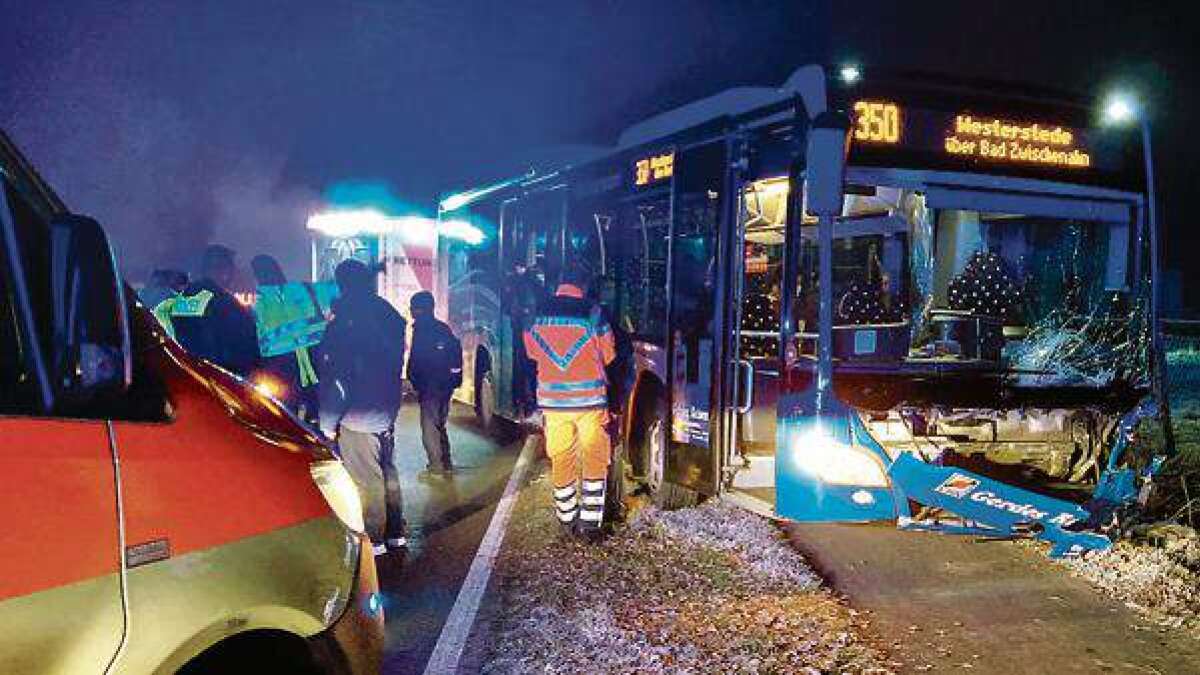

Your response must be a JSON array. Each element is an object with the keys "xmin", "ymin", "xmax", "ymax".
[{"xmin": 523, "ymin": 265, "xmax": 616, "ymax": 542}]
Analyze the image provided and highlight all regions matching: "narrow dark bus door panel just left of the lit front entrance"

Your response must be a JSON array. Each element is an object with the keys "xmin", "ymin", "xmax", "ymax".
[{"xmin": 664, "ymin": 139, "xmax": 737, "ymax": 494}]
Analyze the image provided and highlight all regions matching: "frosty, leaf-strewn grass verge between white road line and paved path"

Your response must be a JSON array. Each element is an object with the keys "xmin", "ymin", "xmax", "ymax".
[{"xmin": 482, "ymin": 478, "xmax": 900, "ymax": 674}]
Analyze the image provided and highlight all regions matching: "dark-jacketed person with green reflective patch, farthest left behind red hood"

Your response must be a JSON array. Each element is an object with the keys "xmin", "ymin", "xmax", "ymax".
[{"xmin": 169, "ymin": 245, "xmax": 258, "ymax": 377}]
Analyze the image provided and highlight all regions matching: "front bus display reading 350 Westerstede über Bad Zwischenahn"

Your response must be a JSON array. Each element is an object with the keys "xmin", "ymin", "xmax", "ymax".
[{"xmin": 853, "ymin": 101, "xmax": 1093, "ymax": 169}]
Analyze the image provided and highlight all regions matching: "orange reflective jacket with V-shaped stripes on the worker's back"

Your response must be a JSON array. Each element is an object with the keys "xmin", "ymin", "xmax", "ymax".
[{"xmin": 524, "ymin": 283, "xmax": 616, "ymax": 410}]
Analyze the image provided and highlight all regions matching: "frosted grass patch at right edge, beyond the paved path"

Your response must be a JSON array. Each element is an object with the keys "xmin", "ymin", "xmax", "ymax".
[{"xmin": 1062, "ymin": 524, "xmax": 1200, "ymax": 634}]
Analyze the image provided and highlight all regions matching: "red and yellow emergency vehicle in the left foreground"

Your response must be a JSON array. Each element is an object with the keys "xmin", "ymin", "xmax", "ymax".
[{"xmin": 0, "ymin": 133, "xmax": 383, "ymax": 674}]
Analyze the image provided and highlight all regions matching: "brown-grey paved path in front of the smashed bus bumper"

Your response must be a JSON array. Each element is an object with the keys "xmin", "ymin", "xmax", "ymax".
[{"xmin": 786, "ymin": 524, "xmax": 1200, "ymax": 675}]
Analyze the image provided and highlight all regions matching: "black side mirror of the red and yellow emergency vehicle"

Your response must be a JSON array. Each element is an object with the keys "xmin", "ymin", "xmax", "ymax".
[{"xmin": 47, "ymin": 215, "xmax": 133, "ymax": 410}]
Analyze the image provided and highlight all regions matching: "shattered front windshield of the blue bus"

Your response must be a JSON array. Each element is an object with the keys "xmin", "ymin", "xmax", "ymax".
[{"xmin": 796, "ymin": 185, "xmax": 1148, "ymax": 387}]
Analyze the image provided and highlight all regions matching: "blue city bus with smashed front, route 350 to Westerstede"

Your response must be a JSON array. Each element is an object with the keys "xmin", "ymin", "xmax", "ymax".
[{"xmin": 438, "ymin": 66, "xmax": 1162, "ymax": 555}]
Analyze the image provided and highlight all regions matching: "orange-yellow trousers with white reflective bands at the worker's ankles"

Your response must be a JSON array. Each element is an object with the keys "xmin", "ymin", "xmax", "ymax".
[{"xmin": 542, "ymin": 408, "xmax": 612, "ymax": 527}]
